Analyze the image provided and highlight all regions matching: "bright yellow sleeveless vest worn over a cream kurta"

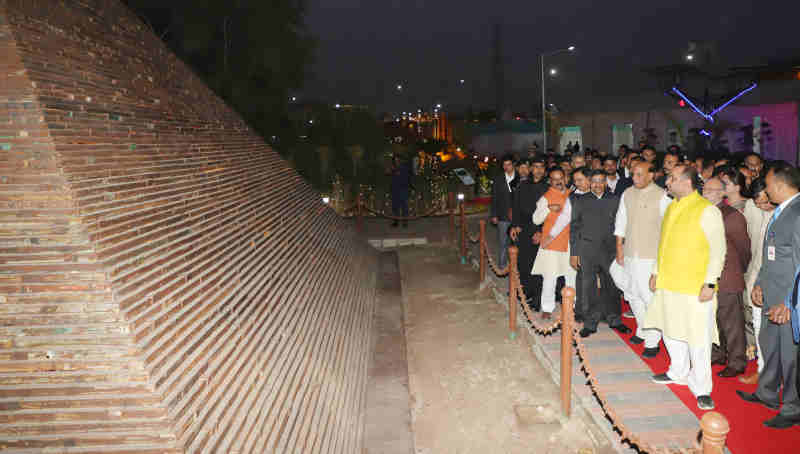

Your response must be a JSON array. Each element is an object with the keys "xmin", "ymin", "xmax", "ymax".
[{"xmin": 656, "ymin": 192, "xmax": 711, "ymax": 295}]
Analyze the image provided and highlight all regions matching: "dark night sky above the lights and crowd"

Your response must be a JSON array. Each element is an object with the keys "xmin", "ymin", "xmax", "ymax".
[{"xmin": 303, "ymin": 0, "xmax": 800, "ymax": 111}]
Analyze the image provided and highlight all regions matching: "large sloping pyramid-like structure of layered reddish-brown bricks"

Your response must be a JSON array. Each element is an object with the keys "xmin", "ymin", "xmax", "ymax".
[{"xmin": 0, "ymin": 0, "xmax": 376, "ymax": 454}]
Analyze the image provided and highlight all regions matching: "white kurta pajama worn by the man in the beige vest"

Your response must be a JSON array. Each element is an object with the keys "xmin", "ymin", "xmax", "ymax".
[{"xmin": 614, "ymin": 193, "xmax": 672, "ymax": 348}]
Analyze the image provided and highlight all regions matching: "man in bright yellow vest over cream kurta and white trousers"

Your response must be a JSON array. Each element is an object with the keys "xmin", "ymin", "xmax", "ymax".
[{"xmin": 645, "ymin": 165, "xmax": 726, "ymax": 410}]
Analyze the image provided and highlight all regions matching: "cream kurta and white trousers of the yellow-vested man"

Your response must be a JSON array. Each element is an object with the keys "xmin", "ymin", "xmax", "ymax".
[{"xmin": 645, "ymin": 206, "xmax": 726, "ymax": 396}]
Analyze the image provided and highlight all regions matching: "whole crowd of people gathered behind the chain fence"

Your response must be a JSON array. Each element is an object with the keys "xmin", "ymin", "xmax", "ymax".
[{"xmin": 490, "ymin": 144, "xmax": 800, "ymax": 428}]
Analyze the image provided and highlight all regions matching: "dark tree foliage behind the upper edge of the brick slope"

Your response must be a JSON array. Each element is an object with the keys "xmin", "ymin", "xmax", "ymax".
[{"xmin": 125, "ymin": 0, "xmax": 316, "ymax": 147}]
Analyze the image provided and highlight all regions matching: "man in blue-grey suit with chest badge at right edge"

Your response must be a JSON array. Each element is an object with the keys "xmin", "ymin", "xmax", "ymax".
[{"xmin": 736, "ymin": 162, "xmax": 800, "ymax": 429}]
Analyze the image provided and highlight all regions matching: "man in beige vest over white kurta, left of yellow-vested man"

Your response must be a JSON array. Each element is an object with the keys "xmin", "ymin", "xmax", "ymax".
[{"xmin": 612, "ymin": 162, "xmax": 672, "ymax": 358}]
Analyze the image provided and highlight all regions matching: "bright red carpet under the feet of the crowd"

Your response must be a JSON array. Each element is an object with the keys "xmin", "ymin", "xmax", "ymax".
[{"xmin": 614, "ymin": 303, "xmax": 800, "ymax": 454}]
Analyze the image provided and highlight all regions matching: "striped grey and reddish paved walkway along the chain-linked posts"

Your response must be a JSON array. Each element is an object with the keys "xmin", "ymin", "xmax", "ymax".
[{"xmin": 468, "ymin": 217, "xmax": 699, "ymax": 452}]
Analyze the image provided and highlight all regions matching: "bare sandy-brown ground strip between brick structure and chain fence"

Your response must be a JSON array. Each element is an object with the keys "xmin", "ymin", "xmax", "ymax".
[{"xmin": 398, "ymin": 246, "xmax": 613, "ymax": 454}]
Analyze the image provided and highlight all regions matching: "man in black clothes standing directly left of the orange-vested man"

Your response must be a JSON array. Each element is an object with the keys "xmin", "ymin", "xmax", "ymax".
[{"xmin": 511, "ymin": 158, "xmax": 548, "ymax": 310}]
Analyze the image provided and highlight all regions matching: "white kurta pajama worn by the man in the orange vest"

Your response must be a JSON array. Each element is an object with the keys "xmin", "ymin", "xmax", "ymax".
[{"xmin": 531, "ymin": 197, "xmax": 577, "ymax": 313}]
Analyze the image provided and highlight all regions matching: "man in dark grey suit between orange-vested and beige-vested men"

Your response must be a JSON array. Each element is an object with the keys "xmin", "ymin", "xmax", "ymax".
[{"xmin": 569, "ymin": 170, "xmax": 630, "ymax": 337}]
